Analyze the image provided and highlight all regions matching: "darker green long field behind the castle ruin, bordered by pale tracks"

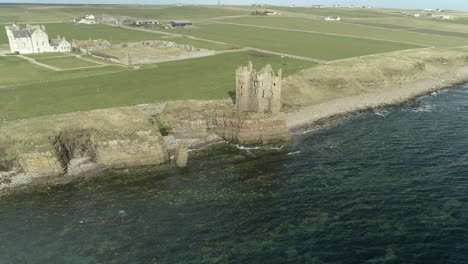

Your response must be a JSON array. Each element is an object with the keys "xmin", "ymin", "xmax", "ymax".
[{"xmin": 172, "ymin": 24, "xmax": 421, "ymax": 60}]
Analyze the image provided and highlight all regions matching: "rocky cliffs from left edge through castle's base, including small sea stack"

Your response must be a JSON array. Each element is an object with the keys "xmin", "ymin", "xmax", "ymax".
[{"xmin": 0, "ymin": 101, "xmax": 290, "ymax": 194}]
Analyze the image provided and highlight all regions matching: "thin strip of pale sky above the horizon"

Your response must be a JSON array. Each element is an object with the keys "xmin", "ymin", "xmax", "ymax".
[{"xmin": 0, "ymin": 0, "xmax": 468, "ymax": 11}]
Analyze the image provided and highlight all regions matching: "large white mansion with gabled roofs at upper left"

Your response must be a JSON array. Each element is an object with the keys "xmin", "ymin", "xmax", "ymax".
[{"xmin": 5, "ymin": 25, "xmax": 71, "ymax": 54}]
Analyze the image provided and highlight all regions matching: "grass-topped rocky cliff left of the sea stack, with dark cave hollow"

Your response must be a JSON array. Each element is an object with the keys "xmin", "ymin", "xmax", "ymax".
[{"xmin": 0, "ymin": 108, "xmax": 169, "ymax": 194}]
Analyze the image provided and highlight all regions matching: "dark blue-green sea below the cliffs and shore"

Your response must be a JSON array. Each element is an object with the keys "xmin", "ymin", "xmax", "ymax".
[{"xmin": 0, "ymin": 85, "xmax": 468, "ymax": 264}]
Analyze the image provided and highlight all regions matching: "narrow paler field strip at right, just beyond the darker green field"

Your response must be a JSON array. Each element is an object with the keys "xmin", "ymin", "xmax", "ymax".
[{"xmin": 219, "ymin": 17, "xmax": 466, "ymax": 47}]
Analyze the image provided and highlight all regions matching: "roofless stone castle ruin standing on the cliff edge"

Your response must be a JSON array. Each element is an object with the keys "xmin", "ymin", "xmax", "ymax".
[{"xmin": 236, "ymin": 62, "xmax": 282, "ymax": 114}]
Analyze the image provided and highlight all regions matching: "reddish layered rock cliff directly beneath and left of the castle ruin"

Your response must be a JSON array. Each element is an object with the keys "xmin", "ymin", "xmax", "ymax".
[{"xmin": 161, "ymin": 101, "xmax": 291, "ymax": 146}]
